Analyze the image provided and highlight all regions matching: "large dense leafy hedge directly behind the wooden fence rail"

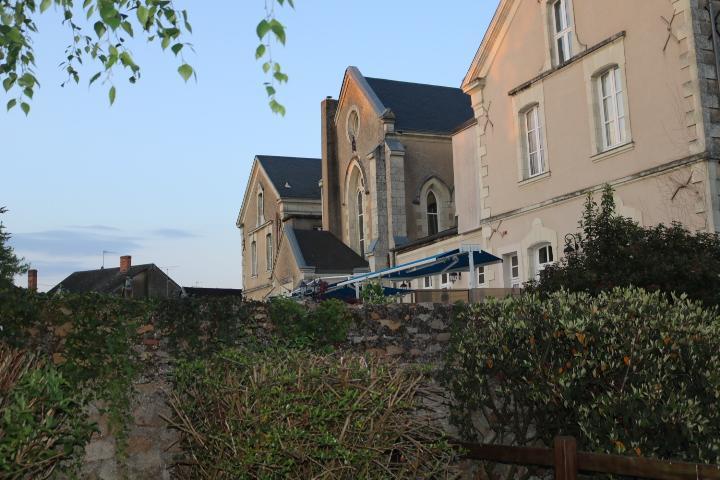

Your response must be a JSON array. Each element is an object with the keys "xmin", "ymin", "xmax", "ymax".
[{"xmin": 444, "ymin": 288, "xmax": 720, "ymax": 472}]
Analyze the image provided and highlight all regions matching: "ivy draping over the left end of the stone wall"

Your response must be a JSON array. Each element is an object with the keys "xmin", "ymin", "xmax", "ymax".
[{"xmin": 0, "ymin": 288, "xmax": 149, "ymax": 447}]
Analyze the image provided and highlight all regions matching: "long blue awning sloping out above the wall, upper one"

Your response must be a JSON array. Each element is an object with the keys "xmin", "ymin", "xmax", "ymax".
[{"xmin": 334, "ymin": 247, "xmax": 502, "ymax": 287}]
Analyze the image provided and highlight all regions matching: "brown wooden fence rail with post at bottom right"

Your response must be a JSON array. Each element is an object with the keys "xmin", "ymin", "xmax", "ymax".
[{"xmin": 459, "ymin": 437, "xmax": 720, "ymax": 480}]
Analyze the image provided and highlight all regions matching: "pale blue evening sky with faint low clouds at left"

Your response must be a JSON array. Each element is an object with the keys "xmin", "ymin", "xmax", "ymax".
[{"xmin": 0, "ymin": 0, "xmax": 497, "ymax": 290}]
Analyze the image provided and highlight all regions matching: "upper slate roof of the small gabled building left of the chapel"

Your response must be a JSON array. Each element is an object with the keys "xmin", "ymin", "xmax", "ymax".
[{"xmin": 257, "ymin": 155, "xmax": 322, "ymax": 200}]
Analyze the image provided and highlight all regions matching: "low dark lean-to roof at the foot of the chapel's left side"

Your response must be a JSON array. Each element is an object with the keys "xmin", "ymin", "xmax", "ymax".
[{"xmin": 293, "ymin": 229, "xmax": 368, "ymax": 273}]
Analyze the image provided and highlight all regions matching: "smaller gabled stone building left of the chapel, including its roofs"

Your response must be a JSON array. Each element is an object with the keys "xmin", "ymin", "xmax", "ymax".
[{"xmin": 236, "ymin": 155, "xmax": 367, "ymax": 300}]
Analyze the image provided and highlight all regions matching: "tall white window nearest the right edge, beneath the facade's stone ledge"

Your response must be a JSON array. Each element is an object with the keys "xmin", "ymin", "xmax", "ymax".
[{"xmin": 598, "ymin": 67, "xmax": 627, "ymax": 150}]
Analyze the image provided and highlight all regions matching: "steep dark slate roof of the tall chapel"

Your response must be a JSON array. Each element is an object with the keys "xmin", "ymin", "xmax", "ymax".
[{"xmin": 365, "ymin": 77, "xmax": 474, "ymax": 134}]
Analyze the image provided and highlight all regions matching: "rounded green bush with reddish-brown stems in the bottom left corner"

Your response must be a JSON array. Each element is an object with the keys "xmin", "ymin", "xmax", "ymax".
[{"xmin": 0, "ymin": 345, "xmax": 94, "ymax": 479}]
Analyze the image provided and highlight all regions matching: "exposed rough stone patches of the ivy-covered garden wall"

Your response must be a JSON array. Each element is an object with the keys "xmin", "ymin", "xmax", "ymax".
[{"xmin": 33, "ymin": 303, "xmax": 453, "ymax": 480}]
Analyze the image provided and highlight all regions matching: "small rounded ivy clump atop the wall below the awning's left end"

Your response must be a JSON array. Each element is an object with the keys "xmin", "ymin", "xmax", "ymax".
[{"xmin": 270, "ymin": 297, "xmax": 351, "ymax": 346}]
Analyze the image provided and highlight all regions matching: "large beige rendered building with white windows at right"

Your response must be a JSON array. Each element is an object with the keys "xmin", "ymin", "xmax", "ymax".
[{"xmin": 394, "ymin": 0, "xmax": 720, "ymax": 288}]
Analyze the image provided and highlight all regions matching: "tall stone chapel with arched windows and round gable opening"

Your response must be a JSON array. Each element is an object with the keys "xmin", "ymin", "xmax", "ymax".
[{"xmin": 322, "ymin": 67, "xmax": 473, "ymax": 271}]
